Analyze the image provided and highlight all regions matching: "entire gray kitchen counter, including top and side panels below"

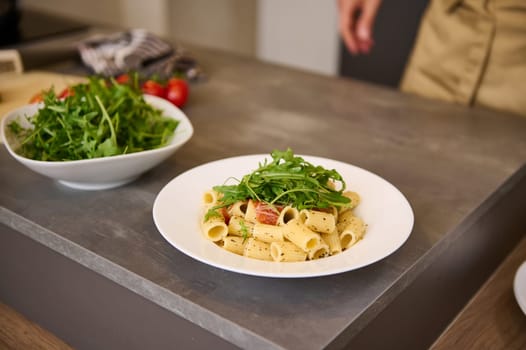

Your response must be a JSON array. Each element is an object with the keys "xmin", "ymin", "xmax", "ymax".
[{"xmin": 0, "ymin": 36, "xmax": 526, "ymax": 350}]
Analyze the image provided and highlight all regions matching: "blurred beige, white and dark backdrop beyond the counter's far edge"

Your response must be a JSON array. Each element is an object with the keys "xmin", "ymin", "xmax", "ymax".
[{"xmin": 18, "ymin": 0, "xmax": 428, "ymax": 86}]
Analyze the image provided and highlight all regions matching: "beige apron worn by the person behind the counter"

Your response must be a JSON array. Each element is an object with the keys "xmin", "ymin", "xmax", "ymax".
[{"xmin": 400, "ymin": 0, "xmax": 526, "ymax": 117}]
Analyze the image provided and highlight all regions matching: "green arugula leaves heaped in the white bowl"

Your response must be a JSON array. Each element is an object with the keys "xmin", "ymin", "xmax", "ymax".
[{"xmin": 9, "ymin": 77, "xmax": 179, "ymax": 161}]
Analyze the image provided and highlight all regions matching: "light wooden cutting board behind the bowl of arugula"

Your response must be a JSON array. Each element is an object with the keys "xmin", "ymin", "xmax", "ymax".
[{"xmin": 0, "ymin": 71, "xmax": 83, "ymax": 118}]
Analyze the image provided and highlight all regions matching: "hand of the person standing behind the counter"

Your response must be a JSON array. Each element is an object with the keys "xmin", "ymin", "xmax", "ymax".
[{"xmin": 338, "ymin": 0, "xmax": 382, "ymax": 55}]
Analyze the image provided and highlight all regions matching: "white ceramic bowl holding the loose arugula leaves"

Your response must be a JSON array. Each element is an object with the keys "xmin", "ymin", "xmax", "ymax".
[{"xmin": 1, "ymin": 95, "xmax": 194, "ymax": 190}]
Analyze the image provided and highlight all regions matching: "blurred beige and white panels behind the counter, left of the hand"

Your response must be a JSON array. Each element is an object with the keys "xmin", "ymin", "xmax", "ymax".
[{"xmin": 20, "ymin": 0, "xmax": 338, "ymax": 74}]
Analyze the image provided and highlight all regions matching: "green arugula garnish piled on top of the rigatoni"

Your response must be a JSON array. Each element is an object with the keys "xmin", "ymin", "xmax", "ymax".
[{"xmin": 205, "ymin": 148, "xmax": 350, "ymax": 220}]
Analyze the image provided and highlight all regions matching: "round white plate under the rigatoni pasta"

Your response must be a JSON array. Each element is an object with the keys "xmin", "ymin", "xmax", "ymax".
[{"xmin": 153, "ymin": 154, "xmax": 414, "ymax": 277}]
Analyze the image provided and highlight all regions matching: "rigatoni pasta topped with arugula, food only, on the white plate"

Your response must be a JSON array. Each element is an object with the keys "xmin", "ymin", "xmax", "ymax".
[{"xmin": 201, "ymin": 149, "xmax": 367, "ymax": 262}]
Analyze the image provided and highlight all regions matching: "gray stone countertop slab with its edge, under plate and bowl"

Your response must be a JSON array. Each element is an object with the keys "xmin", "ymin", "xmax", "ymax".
[{"xmin": 0, "ymin": 41, "xmax": 526, "ymax": 349}]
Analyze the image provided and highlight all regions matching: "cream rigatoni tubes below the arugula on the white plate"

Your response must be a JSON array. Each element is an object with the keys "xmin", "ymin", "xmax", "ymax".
[{"xmin": 201, "ymin": 196, "xmax": 367, "ymax": 262}]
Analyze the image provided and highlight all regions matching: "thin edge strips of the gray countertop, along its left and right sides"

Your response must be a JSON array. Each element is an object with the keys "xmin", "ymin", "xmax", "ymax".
[{"xmin": 4, "ymin": 164, "xmax": 526, "ymax": 349}]
